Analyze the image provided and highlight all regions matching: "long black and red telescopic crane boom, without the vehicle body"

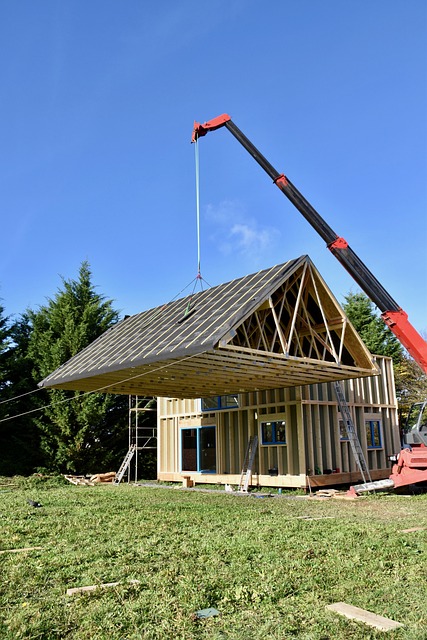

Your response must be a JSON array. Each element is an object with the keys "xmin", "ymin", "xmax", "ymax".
[{"xmin": 192, "ymin": 114, "xmax": 427, "ymax": 373}]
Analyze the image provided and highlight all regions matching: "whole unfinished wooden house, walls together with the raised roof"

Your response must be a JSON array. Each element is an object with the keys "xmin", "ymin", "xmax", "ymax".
[{"xmin": 40, "ymin": 256, "xmax": 398, "ymax": 486}]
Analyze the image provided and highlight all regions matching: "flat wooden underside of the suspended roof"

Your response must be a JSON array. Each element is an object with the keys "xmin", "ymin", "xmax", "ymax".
[{"xmin": 42, "ymin": 348, "xmax": 377, "ymax": 398}]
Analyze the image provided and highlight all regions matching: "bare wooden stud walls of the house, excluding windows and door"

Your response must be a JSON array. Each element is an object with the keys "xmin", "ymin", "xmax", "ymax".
[{"xmin": 158, "ymin": 357, "xmax": 400, "ymax": 486}]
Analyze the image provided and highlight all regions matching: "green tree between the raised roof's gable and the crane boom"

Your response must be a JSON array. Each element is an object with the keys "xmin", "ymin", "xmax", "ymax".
[{"xmin": 343, "ymin": 293, "xmax": 403, "ymax": 365}]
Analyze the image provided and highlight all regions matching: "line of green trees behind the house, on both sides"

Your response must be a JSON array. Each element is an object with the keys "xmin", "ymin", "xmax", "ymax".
[{"xmin": 0, "ymin": 262, "xmax": 427, "ymax": 475}]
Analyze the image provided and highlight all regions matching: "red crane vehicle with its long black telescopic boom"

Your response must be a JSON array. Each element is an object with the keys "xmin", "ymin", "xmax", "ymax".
[{"xmin": 191, "ymin": 113, "xmax": 427, "ymax": 495}]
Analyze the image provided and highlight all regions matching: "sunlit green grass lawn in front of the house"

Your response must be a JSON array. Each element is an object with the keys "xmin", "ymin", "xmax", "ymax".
[{"xmin": 0, "ymin": 479, "xmax": 427, "ymax": 640}]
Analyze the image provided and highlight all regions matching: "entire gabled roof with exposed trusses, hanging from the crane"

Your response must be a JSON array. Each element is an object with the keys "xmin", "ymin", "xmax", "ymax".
[{"xmin": 40, "ymin": 256, "xmax": 377, "ymax": 398}]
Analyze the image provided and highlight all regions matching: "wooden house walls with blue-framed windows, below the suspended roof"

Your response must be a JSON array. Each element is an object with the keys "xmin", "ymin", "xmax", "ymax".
[{"xmin": 157, "ymin": 356, "xmax": 400, "ymax": 490}]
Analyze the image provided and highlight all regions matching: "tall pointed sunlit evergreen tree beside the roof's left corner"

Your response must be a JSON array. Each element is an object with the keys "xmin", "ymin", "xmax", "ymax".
[{"xmin": 28, "ymin": 262, "xmax": 128, "ymax": 473}]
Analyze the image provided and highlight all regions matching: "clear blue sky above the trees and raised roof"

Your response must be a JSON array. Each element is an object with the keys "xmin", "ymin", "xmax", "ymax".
[{"xmin": 0, "ymin": 0, "xmax": 427, "ymax": 340}]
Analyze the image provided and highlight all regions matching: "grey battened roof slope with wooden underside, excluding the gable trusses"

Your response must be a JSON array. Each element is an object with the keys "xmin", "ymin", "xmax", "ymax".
[{"xmin": 40, "ymin": 256, "xmax": 375, "ymax": 397}]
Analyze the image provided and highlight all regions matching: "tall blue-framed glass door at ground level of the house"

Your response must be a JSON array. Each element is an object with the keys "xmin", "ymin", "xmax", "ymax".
[{"xmin": 181, "ymin": 427, "xmax": 216, "ymax": 473}]
